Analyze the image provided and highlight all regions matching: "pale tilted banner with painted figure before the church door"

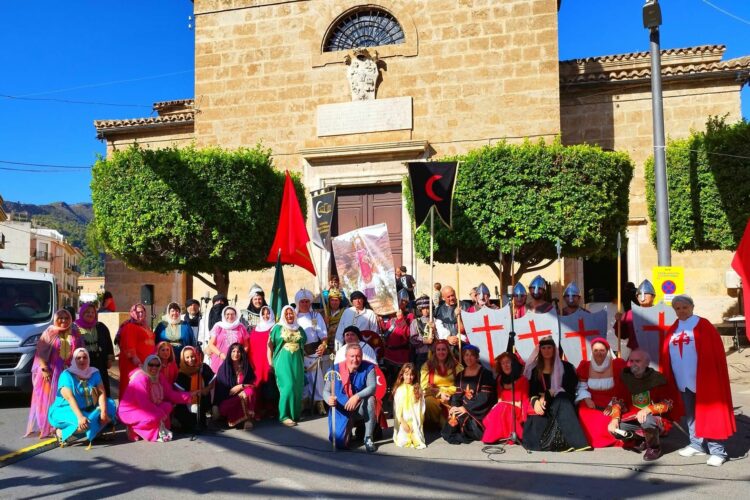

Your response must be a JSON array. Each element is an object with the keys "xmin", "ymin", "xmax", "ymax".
[{"xmin": 331, "ymin": 224, "xmax": 398, "ymax": 315}]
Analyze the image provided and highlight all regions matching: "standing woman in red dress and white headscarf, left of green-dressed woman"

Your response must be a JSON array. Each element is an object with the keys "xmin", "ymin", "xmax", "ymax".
[{"xmin": 250, "ymin": 306, "xmax": 279, "ymax": 420}]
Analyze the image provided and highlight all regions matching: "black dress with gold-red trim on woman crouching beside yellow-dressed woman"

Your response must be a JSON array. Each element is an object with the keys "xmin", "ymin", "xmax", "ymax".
[{"xmin": 441, "ymin": 367, "xmax": 497, "ymax": 444}]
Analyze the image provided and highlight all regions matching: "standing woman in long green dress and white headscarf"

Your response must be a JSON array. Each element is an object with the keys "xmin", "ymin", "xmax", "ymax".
[{"xmin": 268, "ymin": 306, "xmax": 307, "ymax": 427}]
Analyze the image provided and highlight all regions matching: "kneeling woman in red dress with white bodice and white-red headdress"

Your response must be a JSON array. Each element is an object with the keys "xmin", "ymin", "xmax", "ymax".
[{"xmin": 576, "ymin": 337, "xmax": 628, "ymax": 448}]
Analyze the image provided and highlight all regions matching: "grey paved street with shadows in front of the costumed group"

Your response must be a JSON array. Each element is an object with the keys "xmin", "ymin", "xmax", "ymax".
[{"xmin": 0, "ymin": 353, "xmax": 750, "ymax": 499}]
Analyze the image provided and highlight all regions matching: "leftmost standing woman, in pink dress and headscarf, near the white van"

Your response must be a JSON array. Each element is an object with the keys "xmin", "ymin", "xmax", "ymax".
[{"xmin": 25, "ymin": 309, "xmax": 84, "ymax": 439}]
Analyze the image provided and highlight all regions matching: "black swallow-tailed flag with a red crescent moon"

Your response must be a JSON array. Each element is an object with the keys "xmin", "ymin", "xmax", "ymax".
[{"xmin": 407, "ymin": 161, "xmax": 458, "ymax": 227}]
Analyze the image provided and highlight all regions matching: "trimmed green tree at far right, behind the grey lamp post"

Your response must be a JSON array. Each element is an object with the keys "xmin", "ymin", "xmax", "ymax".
[{"xmin": 646, "ymin": 117, "xmax": 750, "ymax": 252}]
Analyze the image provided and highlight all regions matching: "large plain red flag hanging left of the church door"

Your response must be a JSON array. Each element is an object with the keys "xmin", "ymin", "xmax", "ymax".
[{"xmin": 266, "ymin": 171, "xmax": 315, "ymax": 276}]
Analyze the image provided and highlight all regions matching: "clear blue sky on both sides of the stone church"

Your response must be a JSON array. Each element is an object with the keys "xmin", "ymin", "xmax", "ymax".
[{"xmin": 0, "ymin": 0, "xmax": 750, "ymax": 203}]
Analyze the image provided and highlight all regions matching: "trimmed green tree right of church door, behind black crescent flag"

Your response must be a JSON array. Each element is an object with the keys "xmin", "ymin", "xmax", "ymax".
[{"xmin": 404, "ymin": 140, "xmax": 633, "ymax": 292}]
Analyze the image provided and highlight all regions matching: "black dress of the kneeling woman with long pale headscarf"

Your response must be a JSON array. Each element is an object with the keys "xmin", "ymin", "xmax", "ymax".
[{"xmin": 523, "ymin": 361, "xmax": 589, "ymax": 451}]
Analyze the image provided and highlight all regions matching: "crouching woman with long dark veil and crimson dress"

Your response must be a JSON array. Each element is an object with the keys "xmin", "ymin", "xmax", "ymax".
[{"xmin": 214, "ymin": 343, "xmax": 255, "ymax": 431}]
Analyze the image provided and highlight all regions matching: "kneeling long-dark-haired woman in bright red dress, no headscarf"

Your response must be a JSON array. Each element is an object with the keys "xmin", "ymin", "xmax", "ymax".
[{"xmin": 482, "ymin": 352, "xmax": 529, "ymax": 444}]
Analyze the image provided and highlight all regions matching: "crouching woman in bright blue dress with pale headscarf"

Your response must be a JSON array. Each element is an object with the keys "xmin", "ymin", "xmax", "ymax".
[{"xmin": 48, "ymin": 347, "xmax": 115, "ymax": 448}]
